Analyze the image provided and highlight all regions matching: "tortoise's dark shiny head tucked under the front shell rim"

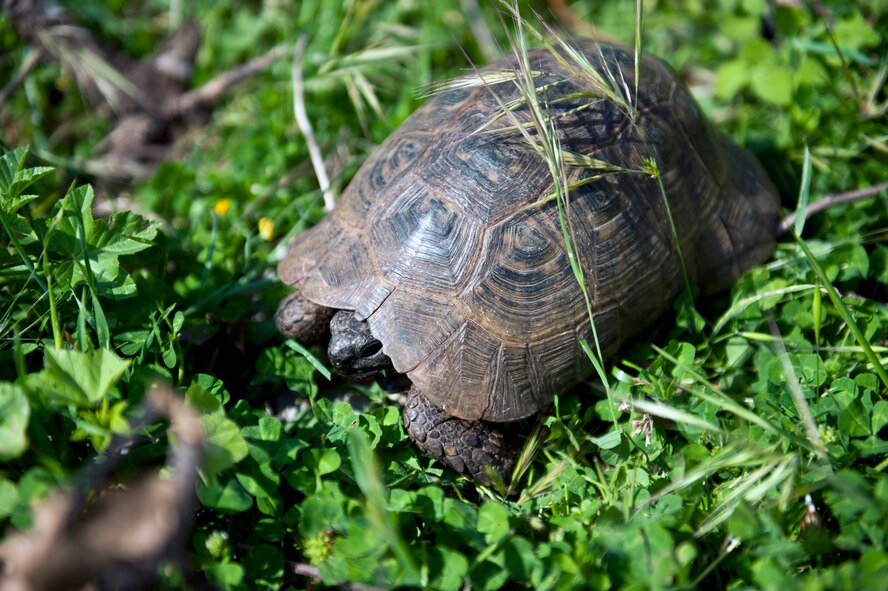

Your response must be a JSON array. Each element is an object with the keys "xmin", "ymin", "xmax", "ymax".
[{"xmin": 327, "ymin": 310, "xmax": 394, "ymax": 377}]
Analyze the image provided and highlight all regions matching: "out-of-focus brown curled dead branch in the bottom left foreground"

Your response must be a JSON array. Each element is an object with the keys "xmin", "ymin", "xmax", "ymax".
[{"xmin": 0, "ymin": 387, "xmax": 204, "ymax": 591}]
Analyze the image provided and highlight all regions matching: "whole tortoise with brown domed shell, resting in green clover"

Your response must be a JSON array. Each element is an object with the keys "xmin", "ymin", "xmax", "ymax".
[{"xmin": 275, "ymin": 42, "xmax": 778, "ymax": 484}]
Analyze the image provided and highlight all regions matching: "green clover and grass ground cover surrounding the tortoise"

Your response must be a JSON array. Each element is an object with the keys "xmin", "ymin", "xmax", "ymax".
[{"xmin": 0, "ymin": 0, "xmax": 888, "ymax": 589}]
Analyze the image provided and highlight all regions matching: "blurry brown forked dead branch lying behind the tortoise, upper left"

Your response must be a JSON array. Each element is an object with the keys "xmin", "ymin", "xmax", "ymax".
[{"xmin": 0, "ymin": 0, "xmax": 286, "ymax": 184}]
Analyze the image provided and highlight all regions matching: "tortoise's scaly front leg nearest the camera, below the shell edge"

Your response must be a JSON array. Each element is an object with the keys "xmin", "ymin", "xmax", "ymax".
[{"xmin": 404, "ymin": 387, "xmax": 515, "ymax": 486}]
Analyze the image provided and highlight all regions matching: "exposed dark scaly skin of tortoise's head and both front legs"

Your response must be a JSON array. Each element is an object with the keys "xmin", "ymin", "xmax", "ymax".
[{"xmin": 274, "ymin": 292, "xmax": 515, "ymax": 485}]
